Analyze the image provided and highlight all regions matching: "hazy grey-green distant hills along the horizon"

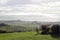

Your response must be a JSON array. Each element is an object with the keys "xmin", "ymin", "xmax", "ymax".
[{"xmin": 0, "ymin": 20, "xmax": 60, "ymax": 27}]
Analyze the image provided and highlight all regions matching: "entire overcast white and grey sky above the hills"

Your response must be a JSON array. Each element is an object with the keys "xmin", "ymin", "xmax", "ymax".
[{"xmin": 0, "ymin": 0, "xmax": 60, "ymax": 22}]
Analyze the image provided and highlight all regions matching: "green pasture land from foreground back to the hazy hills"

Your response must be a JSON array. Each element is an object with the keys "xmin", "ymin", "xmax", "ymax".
[{"xmin": 0, "ymin": 22, "xmax": 60, "ymax": 40}]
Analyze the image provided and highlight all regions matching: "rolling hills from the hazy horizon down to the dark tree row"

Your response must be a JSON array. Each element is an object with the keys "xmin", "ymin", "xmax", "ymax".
[{"xmin": 0, "ymin": 20, "xmax": 60, "ymax": 31}]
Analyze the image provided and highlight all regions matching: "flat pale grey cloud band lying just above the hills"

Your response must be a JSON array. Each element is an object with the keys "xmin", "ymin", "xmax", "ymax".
[{"xmin": 0, "ymin": 15, "xmax": 58, "ymax": 22}]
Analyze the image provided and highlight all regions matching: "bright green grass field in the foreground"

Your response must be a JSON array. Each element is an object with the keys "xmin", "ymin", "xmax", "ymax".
[{"xmin": 0, "ymin": 32, "xmax": 60, "ymax": 40}]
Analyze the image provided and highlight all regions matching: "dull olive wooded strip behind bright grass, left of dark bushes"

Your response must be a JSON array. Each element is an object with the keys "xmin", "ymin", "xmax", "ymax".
[{"xmin": 0, "ymin": 23, "xmax": 36, "ymax": 33}]
